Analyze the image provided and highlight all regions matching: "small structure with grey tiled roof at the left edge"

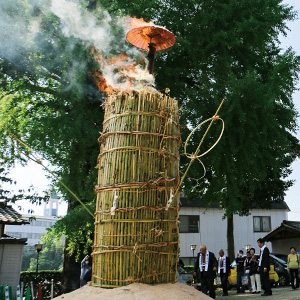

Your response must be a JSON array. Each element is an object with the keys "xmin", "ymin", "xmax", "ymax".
[{"xmin": 0, "ymin": 201, "xmax": 29, "ymax": 295}]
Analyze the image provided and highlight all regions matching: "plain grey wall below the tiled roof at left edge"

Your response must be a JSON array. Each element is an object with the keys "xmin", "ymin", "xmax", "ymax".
[{"xmin": 0, "ymin": 244, "xmax": 24, "ymax": 294}]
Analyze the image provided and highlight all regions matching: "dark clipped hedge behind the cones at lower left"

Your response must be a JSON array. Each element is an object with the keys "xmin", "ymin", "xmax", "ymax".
[{"xmin": 20, "ymin": 271, "xmax": 62, "ymax": 300}]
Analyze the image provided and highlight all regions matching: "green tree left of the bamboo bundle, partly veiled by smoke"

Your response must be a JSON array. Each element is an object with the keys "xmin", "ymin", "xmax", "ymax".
[{"xmin": 0, "ymin": 0, "xmax": 103, "ymax": 292}]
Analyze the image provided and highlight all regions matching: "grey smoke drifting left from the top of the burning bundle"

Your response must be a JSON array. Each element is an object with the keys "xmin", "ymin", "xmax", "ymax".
[{"xmin": 0, "ymin": 0, "xmax": 154, "ymax": 89}]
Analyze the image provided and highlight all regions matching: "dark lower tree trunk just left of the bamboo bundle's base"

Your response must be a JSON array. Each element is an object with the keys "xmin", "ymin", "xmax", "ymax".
[{"xmin": 62, "ymin": 240, "xmax": 80, "ymax": 293}]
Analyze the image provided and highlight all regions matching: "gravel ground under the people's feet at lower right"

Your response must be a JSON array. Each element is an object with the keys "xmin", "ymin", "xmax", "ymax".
[{"xmin": 216, "ymin": 286, "xmax": 300, "ymax": 300}]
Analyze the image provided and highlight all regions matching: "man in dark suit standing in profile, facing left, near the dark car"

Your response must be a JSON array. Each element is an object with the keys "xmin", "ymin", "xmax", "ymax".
[{"xmin": 257, "ymin": 239, "xmax": 272, "ymax": 296}]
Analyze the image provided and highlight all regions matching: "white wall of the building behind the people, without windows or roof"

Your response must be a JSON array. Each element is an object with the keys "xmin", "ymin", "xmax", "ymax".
[{"xmin": 179, "ymin": 207, "xmax": 287, "ymax": 264}]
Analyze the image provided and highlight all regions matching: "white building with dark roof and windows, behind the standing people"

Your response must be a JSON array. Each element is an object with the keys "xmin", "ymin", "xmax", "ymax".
[{"xmin": 179, "ymin": 197, "xmax": 289, "ymax": 264}]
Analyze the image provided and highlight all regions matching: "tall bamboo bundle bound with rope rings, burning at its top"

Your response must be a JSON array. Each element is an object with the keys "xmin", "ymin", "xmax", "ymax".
[{"xmin": 92, "ymin": 90, "xmax": 181, "ymax": 287}]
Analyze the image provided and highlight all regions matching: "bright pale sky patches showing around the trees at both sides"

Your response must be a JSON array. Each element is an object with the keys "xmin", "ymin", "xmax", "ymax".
[{"xmin": 4, "ymin": 0, "xmax": 300, "ymax": 221}]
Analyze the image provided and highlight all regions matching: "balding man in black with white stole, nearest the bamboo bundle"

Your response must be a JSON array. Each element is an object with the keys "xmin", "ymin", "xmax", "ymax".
[{"xmin": 194, "ymin": 245, "xmax": 218, "ymax": 299}]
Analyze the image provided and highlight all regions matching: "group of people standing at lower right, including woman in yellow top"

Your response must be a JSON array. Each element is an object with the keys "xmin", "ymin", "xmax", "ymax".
[{"xmin": 194, "ymin": 239, "xmax": 300, "ymax": 299}]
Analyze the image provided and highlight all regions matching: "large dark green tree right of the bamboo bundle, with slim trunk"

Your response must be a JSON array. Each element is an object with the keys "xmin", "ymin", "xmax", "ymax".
[{"xmin": 101, "ymin": 0, "xmax": 299, "ymax": 258}]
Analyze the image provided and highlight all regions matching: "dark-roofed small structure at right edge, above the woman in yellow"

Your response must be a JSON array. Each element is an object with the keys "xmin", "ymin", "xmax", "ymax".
[{"xmin": 264, "ymin": 220, "xmax": 300, "ymax": 254}]
